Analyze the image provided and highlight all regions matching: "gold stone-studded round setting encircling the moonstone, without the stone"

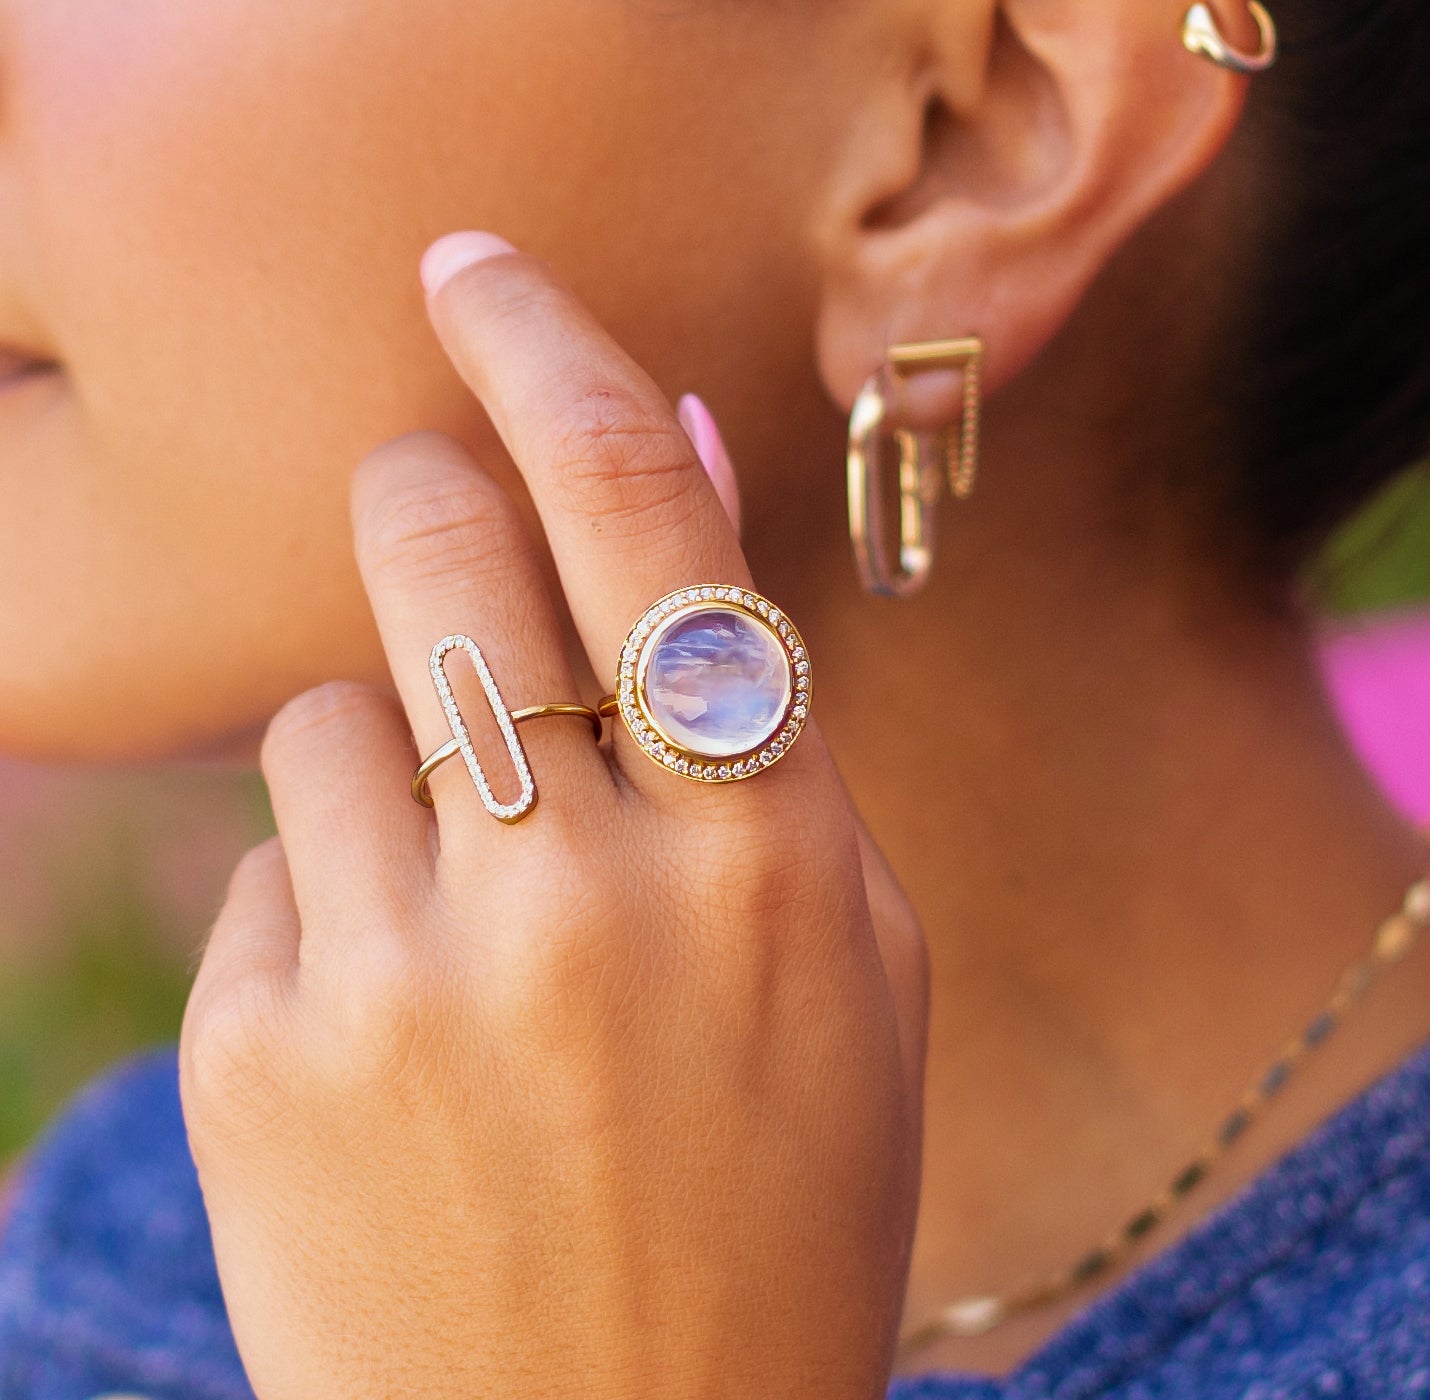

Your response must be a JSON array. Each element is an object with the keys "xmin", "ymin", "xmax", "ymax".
[{"xmin": 616, "ymin": 583, "xmax": 812, "ymax": 782}]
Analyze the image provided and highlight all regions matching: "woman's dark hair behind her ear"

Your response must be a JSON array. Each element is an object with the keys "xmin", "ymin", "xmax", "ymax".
[{"xmin": 1224, "ymin": 0, "xmax": 1430, "ymax": 597}]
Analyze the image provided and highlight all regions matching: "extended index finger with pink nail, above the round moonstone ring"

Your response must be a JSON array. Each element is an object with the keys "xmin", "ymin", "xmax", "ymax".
[{"xmin": 422, "ymin": 233, "xmax": 751, "ymax": 681}]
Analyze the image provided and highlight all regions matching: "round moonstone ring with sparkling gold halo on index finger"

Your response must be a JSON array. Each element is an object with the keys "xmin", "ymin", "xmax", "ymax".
[{"xmin": 601, "ymin": 583, "xmax": 811, "ymax": 782}]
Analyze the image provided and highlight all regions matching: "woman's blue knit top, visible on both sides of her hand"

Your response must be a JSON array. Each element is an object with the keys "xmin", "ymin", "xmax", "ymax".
[{"xmin": 0, "ymin": 1044, "xmax": 1430, "ymax": 1400}]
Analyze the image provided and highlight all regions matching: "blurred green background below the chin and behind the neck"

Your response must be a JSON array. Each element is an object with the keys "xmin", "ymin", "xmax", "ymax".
[{"xmin": 0, "ymin": 470, "xmax": 1430, "ymax": 1165}]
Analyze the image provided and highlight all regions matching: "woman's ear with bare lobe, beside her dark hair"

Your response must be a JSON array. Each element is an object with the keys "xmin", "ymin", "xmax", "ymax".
[{"xmin": 818, "ymin": 0, "xmax": 1247, "ymax": 422}]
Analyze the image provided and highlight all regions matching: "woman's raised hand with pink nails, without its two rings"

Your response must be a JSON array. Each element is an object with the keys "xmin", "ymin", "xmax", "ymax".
[{"xmin": 180, "ymin": 236, "xmax": 927, "ymax": 1400}]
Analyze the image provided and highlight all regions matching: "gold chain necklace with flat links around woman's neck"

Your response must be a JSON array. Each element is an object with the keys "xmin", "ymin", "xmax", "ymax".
[{"xmin": 899, "ymin": 878, "xmax": 1430, "ymax": 1357}]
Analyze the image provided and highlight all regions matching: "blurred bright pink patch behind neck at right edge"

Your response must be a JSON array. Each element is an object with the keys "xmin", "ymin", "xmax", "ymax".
[{"xmin": 1321, "ymin": 608, "xmax": 1430, "ymax": 824}]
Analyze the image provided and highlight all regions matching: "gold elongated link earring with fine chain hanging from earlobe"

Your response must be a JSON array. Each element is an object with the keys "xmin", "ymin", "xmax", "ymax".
[{"xmin": 848, "ymin": 336, "xmax": 984, "ymax": 598}]
